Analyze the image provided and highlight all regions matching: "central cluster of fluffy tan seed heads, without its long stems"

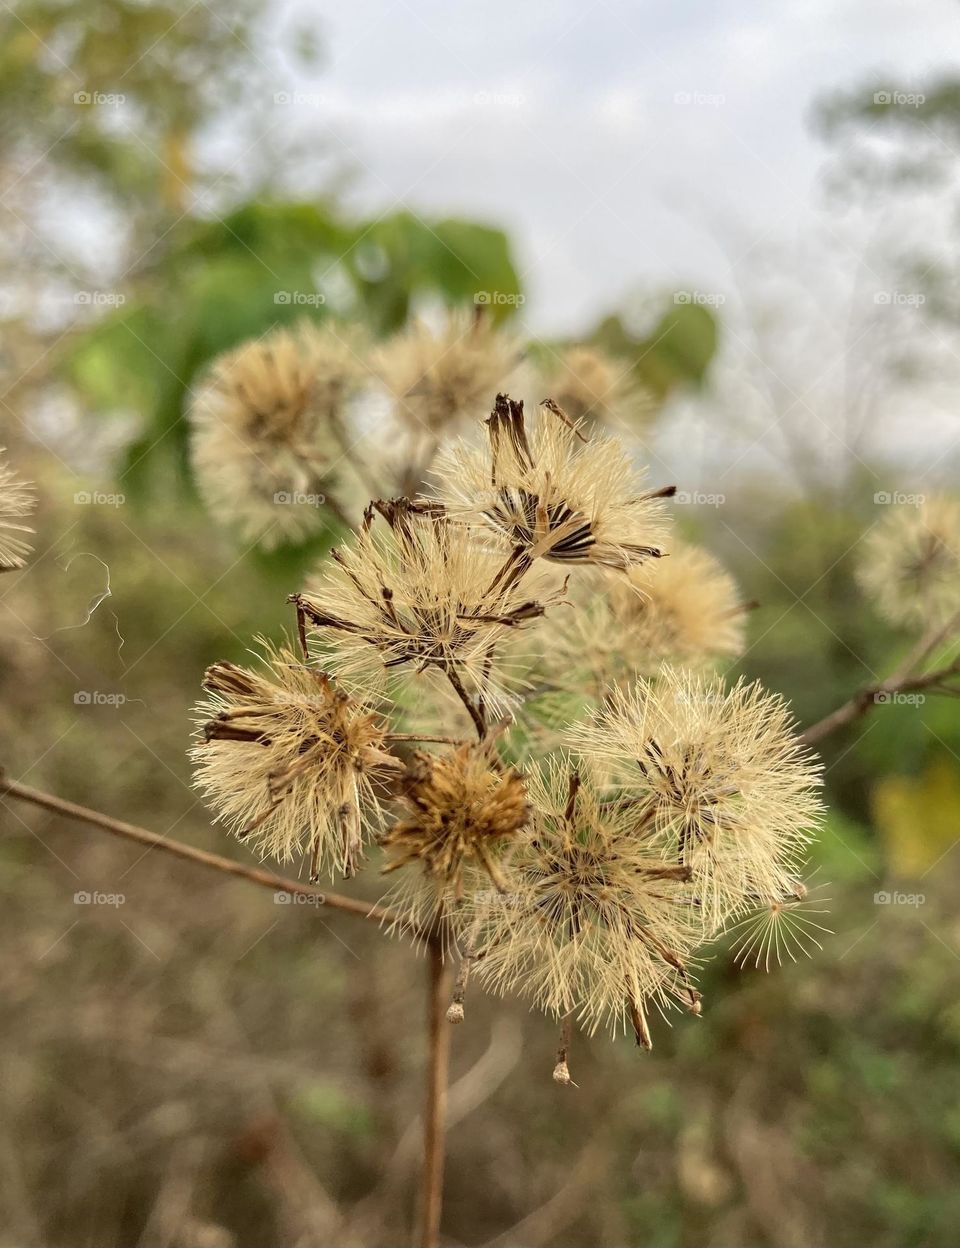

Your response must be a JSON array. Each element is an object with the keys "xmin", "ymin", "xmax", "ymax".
[{"xmin": 193, "ymin": 336, "xmax": 820, "ymax": 1082}]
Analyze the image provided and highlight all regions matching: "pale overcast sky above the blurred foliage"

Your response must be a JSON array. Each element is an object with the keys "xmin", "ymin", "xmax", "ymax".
[{"xmin": 264, "ymin": 0, "xmax": 960, "ymax": 333}]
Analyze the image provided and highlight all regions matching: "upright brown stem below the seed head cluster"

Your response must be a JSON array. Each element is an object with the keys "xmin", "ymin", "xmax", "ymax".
[{"xmin": 419, "ymin": 935, "xmax": 451, "ymax": 1248}]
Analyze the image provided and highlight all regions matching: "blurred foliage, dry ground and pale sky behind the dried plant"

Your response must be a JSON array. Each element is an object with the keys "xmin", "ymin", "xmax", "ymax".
[{"xmin": 0, "ymin": 0, "xmax": 960, "ymax": 1248}]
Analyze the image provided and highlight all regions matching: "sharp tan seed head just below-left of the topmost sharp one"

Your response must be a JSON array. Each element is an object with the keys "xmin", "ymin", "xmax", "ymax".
[{"xmin": 295, "ymin": 499, "xmax": 562, "ymax": 705}]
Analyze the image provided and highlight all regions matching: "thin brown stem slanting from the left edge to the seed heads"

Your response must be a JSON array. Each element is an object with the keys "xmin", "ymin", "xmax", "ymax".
[{"xmin": 0, "ymin": 775, "xmax": 401, "ymax": 924}]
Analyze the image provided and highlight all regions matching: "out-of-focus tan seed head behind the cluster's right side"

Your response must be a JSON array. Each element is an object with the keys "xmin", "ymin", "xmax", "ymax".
[{"xmin": 543, "ymin": 545, "xmax": 748, "ymax": 693}]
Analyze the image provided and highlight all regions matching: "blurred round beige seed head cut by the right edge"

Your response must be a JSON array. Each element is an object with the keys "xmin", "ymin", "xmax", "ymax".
[{"xmin": 858, "ymin": 495, "xmax": 960, "ymax": 628}]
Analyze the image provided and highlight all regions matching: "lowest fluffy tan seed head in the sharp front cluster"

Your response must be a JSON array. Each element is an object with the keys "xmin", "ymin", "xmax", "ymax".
[{"xmin": 463, "ymin": 758, "xmax": 700, "ymax": 1048}]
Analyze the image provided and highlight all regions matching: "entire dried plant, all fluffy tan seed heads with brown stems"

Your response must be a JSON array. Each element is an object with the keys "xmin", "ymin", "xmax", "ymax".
[{"xmin": 20, "ymin": 319, "xmax": 898, "ymax": 1248}]
